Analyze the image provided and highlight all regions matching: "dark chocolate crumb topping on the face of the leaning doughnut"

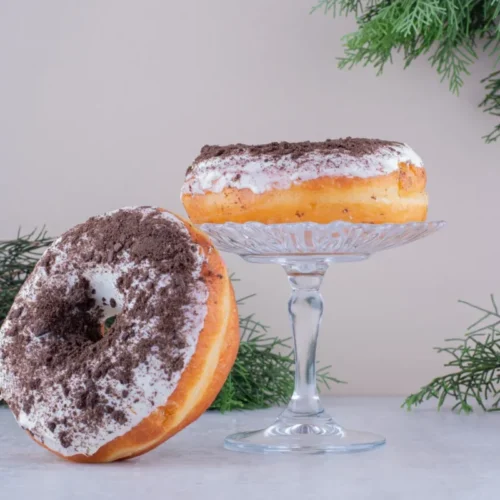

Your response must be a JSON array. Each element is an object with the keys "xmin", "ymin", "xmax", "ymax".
[{"xmin": 0, "ymin": 208, "xmax": 205, "ymax": 454}]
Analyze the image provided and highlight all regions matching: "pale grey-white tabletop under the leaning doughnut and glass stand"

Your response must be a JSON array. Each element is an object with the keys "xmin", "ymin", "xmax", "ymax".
[{"xmin": 0, "ymin": 398, "xmax": 500, "ymax": 500}]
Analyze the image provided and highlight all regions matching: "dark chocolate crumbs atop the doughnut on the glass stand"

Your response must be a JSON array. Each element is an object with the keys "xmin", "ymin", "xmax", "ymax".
[{"xmin": 194, "ymin": 137, "xmax": 402, "ymax": 164}]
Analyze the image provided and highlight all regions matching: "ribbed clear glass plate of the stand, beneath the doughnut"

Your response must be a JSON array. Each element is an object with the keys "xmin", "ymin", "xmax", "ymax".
[{"xmin": 199, "ymin": 221, "xmax": 446, "ymax": 257}]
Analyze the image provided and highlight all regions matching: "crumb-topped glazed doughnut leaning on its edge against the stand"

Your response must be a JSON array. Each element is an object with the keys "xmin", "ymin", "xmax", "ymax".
[{"xmin": 0, "ymin": 207, "xmax": 239, "ymax": 462}]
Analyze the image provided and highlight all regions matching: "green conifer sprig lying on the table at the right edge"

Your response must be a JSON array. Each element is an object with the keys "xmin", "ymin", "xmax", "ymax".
[{"xmin": 403, "ymin": 295, "xmax": 500, "ymax": 413}]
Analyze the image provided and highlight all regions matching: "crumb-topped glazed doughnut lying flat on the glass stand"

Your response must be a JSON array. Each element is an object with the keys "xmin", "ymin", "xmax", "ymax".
[{"xmin": 181, "ymin": 137, "xmax": 427, "ymax": 224}]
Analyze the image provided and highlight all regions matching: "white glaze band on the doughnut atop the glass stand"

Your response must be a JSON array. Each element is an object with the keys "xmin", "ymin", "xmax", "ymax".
[{"xmin": 181, "ymin": 144, "xmax": 423, "ymax": 194}]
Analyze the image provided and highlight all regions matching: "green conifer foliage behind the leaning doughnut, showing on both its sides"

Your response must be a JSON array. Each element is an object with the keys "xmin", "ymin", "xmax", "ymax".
[{"xmin": 0, "ymin": 230, "xmax": 341, "ymax": 412}]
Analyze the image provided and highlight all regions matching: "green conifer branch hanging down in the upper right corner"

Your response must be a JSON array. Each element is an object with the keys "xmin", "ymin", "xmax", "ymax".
[{"xmin": 312, "ymin": 0, "xmax": 500, "ymax": 142}]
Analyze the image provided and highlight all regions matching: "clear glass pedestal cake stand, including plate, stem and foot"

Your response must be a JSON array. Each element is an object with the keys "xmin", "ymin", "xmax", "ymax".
[{"xmin": 201, "ymin": 221, "xmax": 444, "ymax": 453}]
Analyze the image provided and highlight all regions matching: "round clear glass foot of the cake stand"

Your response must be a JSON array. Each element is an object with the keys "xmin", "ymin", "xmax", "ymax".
[{"xmin": 224, "ymin": 410, "xmax": 385, "ymax": 454}]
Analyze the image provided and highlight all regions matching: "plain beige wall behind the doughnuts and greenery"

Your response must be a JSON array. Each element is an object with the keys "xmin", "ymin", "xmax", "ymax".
[{"xmin": 0, "ymin": 0, "xmax": 500, "ymax": 394}]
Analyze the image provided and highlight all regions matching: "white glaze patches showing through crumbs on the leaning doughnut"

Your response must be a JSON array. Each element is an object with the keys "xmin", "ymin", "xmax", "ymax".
[{"xmin": 0, "ymin": 208, "xmax": 208, "ymax": 456}]
